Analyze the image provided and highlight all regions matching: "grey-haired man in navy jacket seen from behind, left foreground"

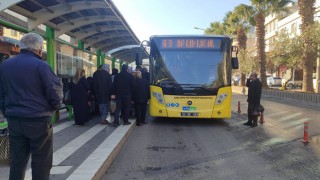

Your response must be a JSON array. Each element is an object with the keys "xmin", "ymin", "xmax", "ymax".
[{"xmin": 0, "ymin": 33, "xmax": 63, "ymax": 180}]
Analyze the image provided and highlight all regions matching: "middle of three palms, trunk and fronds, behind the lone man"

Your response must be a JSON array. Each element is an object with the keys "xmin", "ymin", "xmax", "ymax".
[{"xmin": 244, "ymin": 0, "xmax": 292, "ymax": 87}]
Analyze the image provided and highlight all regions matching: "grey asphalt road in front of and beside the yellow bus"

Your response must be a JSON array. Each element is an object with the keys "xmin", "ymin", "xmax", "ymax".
[{"xmin": 102, "ymin": 94, "xmax": 320, "ymax": 180}]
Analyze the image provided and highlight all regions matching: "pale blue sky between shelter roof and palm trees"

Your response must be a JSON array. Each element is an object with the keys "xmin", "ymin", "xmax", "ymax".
[{"xmin": 113, "ymin": 0, "xmax": 250, "ymax": 41}]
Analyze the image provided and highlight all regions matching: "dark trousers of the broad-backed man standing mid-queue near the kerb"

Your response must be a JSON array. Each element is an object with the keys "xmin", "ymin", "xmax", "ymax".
[{"xmin": 114, "ymin": 96, "xmax": 131, "ymax": 125}]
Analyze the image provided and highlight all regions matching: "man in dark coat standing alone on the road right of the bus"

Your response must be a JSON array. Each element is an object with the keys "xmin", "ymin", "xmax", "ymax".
[{"xmin": 244, "ymin": 72, "xmax": 262, "ymax": 127}]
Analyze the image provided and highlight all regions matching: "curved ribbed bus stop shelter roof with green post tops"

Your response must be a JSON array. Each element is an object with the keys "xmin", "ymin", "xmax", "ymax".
[{"xmin": 0, "ymin": 0, "xmax": 148, "ymax": 68}]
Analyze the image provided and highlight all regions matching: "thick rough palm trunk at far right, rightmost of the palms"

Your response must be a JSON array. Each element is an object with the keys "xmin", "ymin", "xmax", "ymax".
[{"xmin": 298, "ymin": 0, "xmax": 315, "ymax": 92}]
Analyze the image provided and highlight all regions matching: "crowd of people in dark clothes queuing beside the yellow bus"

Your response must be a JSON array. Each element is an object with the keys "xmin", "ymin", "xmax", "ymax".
[{"xmin": 64, "ymin": 64, "xmax": 150, "ymax": 127}]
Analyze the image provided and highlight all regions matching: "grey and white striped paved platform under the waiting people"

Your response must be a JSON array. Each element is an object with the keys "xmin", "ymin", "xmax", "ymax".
[{"xmin": 0, "ymin": 111, "xmax": 135, "ymax": 180}]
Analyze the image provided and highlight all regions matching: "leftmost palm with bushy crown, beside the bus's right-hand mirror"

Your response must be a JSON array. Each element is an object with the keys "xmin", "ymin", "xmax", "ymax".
[{"xmin": 226, "ymin": 4, "xmax": 253, "ymax": 86}]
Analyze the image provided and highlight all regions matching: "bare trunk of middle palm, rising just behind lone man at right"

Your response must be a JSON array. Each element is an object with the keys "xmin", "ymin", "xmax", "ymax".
[{"xmin": 254, "ymin": 13, "xmax": 268, "ymax": 88}]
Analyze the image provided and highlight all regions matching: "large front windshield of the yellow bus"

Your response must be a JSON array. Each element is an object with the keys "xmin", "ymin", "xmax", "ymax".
[{"xmin": 155, "ymin": 51, "xmax": 224, "ymax": 87}]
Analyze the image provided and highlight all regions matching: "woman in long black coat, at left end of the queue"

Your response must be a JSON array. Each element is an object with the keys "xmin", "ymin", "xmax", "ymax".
[{"xmin": 70, "ymin": 68, "xmax": 90, "ymax": 125}]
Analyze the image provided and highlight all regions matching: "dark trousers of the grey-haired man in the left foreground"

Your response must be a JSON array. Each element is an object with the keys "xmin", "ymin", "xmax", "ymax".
[{"xmin": 8, "ymin": 117, "xmax": 53, "ymax": 180}]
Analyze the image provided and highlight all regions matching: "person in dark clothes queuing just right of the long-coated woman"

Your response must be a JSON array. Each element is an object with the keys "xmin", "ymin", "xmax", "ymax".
[{"xmin": 93, "ymin": 64, "xmax": 112, "ymax": 124}]
